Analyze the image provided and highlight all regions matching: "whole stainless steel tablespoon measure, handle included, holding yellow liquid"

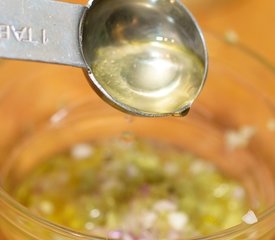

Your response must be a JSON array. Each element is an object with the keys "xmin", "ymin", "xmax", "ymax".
[{"xmin": 0, "ymin": 0, "xmax": 208, "ymax": 117}]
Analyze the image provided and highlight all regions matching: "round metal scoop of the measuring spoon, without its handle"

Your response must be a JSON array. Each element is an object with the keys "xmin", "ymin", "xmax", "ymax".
[{"xmin": 80, "ymin": 0, "xmax": 208, "ymax": 117}]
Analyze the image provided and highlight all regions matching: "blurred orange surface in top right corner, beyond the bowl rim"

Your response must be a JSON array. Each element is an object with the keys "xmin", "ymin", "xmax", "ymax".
[{"xmin": 183, "ymin": 0, "xmax": 275, "ymax": 66}]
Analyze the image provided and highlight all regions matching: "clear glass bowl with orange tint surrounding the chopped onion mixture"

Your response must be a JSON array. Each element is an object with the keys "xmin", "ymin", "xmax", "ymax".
[{"xmin": 0, "ymin": 33, "xmax": 275, "ymax": 240}]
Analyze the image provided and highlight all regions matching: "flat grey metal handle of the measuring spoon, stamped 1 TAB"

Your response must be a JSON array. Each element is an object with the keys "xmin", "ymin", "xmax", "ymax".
[{"xmin": 0, "ymin": 0, "xmax": 86, "ymax": 67}]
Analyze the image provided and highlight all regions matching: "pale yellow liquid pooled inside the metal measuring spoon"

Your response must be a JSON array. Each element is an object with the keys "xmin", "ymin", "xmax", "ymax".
[{"xmin": 91, "ymin": 41, "xmax": 203, "ymax": 113}]
